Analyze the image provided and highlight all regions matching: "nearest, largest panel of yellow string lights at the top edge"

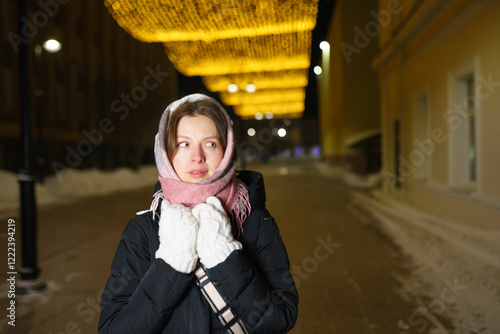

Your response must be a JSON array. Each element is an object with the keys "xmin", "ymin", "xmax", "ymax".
[{"xmin": 104, "ymin": 0, "xmax": 318, "ymax": 42}]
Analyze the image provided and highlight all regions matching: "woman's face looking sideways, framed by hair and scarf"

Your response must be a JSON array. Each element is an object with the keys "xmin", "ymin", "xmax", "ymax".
[{"xmin": 172, "ymin": 115, "xmax": 224, "ymax": 183}]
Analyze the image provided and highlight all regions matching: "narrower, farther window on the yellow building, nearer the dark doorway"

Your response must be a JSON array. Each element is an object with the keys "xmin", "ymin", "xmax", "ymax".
[{"xmin": 410, "ymin": 93, "xmax": 434, "ymax": 182}]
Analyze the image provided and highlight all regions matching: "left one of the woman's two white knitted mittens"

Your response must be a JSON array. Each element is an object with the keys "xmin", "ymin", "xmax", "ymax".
[{"xmin": 156, "ymin": 199, "xmax": 198, "ymax": 274}]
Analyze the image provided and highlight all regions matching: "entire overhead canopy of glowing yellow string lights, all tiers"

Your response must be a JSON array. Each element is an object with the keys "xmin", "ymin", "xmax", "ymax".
[{"xmin": 104, "ymin": 0, "xmax": 318, "ymax": 118}]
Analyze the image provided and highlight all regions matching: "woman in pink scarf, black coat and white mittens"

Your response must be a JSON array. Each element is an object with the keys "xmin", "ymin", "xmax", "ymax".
[{"xmin": 99, "ymin": 94, "xmax": 298, "ymax": 334}]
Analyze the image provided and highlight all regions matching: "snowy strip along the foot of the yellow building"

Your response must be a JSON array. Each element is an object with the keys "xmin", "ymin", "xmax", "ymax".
[{"xmin": 353, "ymin": 192, "xmax": 500, "ymax": 334}]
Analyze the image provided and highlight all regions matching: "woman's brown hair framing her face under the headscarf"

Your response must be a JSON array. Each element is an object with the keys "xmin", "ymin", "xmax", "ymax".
[{"xmin": 165, "ymin": 99, "xmax": 237, "ymax": 163}]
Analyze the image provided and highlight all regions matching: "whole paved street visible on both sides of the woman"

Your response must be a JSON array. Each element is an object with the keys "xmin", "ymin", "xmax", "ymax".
[{"xmin": 0, "ymin": 163, "xmax": 446, "ymax": 334}]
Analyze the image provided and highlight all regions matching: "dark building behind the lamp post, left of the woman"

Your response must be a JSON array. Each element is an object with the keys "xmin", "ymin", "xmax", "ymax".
[{"xmin": 0, "ymin": 0, "xmax": 178, "ymax": 179}]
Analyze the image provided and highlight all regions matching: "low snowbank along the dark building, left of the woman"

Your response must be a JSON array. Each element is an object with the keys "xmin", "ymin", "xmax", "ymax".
[{"xmin": 0, "ymin": 166, "xmax": 158, "ymax": 211}]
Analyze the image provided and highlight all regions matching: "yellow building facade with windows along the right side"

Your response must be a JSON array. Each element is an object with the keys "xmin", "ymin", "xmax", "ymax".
[{"xmin": 372, "ymin": 0, "xmax": 500, "ymax": 230}]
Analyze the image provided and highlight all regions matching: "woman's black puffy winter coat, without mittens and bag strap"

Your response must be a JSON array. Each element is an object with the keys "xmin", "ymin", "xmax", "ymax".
[{"xmin": 99, "ymin": 171, "xmax": 298, "ymax": 334}]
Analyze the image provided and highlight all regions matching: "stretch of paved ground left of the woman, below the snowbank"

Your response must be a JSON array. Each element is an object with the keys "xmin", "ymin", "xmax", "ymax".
[{"xmin": 0, "ymin": 185, "xmax": 154, "ymax": 334}]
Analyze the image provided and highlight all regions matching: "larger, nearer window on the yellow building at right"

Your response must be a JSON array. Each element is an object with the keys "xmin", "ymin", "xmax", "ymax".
[{"xmin": 448, "ymin": 60, "xmax": 479, "ymax": 191}]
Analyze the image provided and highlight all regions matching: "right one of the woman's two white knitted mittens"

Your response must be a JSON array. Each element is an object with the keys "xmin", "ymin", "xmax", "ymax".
[{"xmin": 192, "ymin": 196, "xmax": 242, "ymax": 268}]
